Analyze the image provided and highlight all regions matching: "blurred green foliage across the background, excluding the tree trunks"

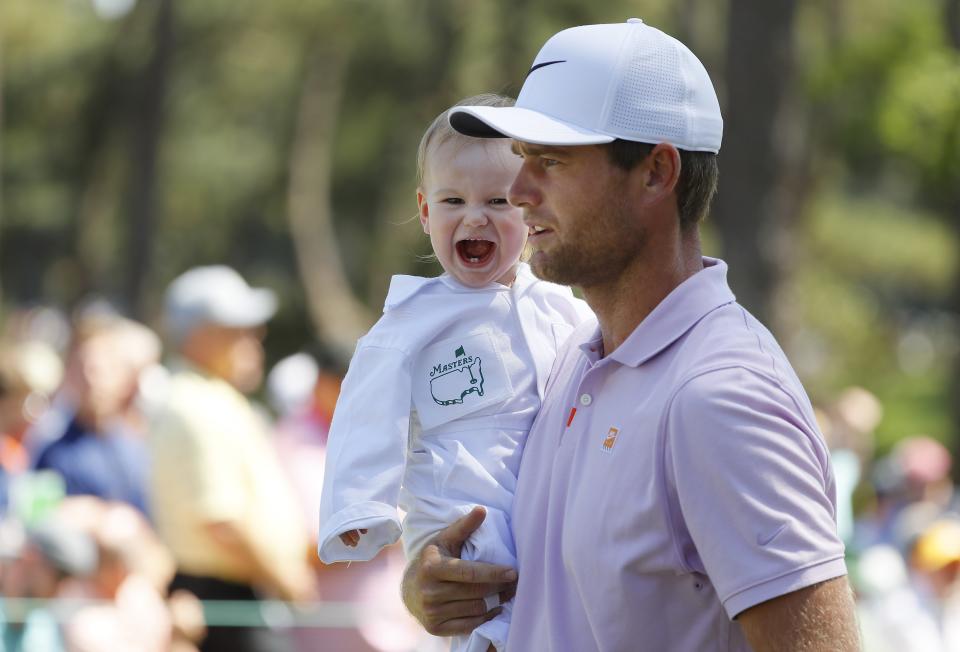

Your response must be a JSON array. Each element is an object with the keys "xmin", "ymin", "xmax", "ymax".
[{"xmin": 0, "ymin": 0, "xmax": 960, "ymax": 446}]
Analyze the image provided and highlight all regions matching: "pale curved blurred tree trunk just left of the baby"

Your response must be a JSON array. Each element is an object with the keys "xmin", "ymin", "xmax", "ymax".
[{"xmin": 287, "ymin": 47, "xmax": 373, "ymax": 352}]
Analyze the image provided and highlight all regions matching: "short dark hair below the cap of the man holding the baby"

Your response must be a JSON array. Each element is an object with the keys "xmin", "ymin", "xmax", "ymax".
[{"xmin": 607, "ymin": 138, "xmax": 720, "ymax": 231}]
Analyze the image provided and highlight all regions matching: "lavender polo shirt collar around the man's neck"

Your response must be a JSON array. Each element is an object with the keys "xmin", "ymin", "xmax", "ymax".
[{"xmin": 609, "ymin": 256, "xmax": 736, "ymax": 367}]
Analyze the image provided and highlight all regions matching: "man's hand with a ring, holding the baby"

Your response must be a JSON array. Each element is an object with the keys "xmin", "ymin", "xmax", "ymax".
[{"xmin": 402, "ymin": 507, "xmax": 517, "ymax": 636}]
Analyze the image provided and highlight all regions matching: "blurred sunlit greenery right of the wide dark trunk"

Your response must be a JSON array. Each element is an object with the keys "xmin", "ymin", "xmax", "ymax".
[{"xmin": 792, "ymin": 0, "xmax": 960, "ymax": 450}]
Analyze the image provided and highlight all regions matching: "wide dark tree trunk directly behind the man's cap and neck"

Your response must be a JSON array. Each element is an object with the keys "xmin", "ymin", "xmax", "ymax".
[{"xmin": 713, "ymin": 0, "xmax": 803, "ymax": 323}]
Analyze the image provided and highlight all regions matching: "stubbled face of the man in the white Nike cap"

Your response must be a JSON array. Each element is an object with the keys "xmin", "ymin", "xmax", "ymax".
[{"xmin": 509, "ymin": 142, "xmax": 646, "ymax": 288}]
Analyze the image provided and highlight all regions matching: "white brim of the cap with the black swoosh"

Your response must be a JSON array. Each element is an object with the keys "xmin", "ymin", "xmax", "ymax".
[{"xmin": 450, "ymin": 106, "xmax": 615, "ymax": 145}]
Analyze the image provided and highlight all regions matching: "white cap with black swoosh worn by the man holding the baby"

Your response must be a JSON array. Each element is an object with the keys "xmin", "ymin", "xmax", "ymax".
[{"xmin": 450, "ymin": 18, "xmax": 723, "ymax": 153}]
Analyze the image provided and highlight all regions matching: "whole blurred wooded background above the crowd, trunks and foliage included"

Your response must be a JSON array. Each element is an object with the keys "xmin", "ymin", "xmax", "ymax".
[{"xmin": 0, "ymin": 0, "xmax": 960, "ymax": 649}]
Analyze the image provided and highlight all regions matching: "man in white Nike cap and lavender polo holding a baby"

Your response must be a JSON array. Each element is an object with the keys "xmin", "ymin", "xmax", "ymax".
[{"xmin": 404, "ymin": 19, "xmax": 859, "ymax": 652}]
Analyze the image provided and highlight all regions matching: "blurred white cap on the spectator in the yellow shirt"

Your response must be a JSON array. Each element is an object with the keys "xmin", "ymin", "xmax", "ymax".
[{"xmin": 164, "ymin": 265, "xmax": 277, "ymax": 339}]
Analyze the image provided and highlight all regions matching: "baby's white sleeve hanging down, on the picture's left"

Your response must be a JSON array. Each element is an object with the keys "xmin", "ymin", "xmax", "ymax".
[{"xmin": 318, "ymin": 343, "xmax": 410, "ymax": 563}]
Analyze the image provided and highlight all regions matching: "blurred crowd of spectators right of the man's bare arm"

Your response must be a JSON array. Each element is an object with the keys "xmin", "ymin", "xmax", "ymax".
[{"xmin": 818, "ymin": 387, "xmax": 960, "ymax": 652}]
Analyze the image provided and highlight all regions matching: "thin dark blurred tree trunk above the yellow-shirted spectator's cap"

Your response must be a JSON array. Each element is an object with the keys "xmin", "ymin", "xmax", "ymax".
[{"xmin": 123, "ymin": 0, "xmax": 174, "ymax": 319}]
